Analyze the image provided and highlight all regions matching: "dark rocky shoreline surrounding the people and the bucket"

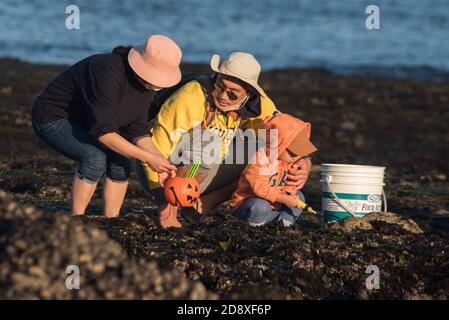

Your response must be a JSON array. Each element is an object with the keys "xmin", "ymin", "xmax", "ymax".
[{"xmin": 0, "ymin": 59, "xmax": 449, "ymax": 299}]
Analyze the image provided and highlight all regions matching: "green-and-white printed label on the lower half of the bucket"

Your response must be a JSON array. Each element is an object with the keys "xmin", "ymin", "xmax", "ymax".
[{"xmin": 322, "ymin": 192, "xmax": 382, "ymax": 215}]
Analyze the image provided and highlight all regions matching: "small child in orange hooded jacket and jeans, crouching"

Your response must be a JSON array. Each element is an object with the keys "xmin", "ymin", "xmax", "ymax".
[{"xmin": 231, "ymin": 113, "xmax": 317, "ymax": 226}]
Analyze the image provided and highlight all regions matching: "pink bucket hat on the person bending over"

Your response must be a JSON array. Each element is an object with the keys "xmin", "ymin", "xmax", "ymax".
[{"xmin": 128, "ymin": 35, "xmax": 182, "ymax": 88}]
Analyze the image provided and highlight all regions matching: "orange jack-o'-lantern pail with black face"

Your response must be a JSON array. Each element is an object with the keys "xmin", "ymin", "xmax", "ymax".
[{"xmin": 164, "ymin": 177, "xmax": 200, "ymax": 207}]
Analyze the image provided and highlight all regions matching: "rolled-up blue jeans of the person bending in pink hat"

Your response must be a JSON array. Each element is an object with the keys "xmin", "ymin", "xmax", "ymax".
[{"xmin": 33, "ymin": 119, "xmax": 131, "ymax": 183}]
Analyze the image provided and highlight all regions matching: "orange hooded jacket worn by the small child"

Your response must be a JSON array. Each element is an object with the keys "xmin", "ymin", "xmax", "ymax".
[{"xmin": 231, "ymin": 113, "xmax": 311, "ymax": 208}]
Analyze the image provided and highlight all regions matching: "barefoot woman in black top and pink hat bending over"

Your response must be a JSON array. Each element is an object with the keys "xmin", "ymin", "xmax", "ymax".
[{"xmin": 32, "ymin": 35, "xmax": 182, "ymax": 217}]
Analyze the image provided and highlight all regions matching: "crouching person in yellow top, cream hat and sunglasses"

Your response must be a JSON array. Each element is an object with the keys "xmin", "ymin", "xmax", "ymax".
[{"xmin": 136, "ymin": 52, "xmax": 310, "ymax": 228}]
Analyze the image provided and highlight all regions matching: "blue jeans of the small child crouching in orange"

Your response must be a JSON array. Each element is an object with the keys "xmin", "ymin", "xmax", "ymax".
[{"xmin": 234, "ymin": 191, "xmax": 305, "ymax": 226}]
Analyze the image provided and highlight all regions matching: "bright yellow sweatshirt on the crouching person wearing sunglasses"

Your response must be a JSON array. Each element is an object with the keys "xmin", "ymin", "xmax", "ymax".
[{"xmin": 143, "ymin": 80, "xmax": 278, "ymax": 189}]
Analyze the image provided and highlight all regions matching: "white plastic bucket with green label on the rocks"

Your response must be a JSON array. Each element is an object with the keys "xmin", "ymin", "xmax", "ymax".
[{"xmin": 320, "ymin": 163, "xmax": 387, "ymax": 221}]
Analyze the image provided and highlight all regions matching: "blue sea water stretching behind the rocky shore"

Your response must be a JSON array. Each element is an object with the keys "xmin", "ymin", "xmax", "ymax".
[{"xmin": 0, "ymin": 0, "xmax": 449, "ymax": 79}]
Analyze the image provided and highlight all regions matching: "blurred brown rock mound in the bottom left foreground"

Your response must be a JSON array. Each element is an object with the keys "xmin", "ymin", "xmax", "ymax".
[{"xmin": 0, "ymin": 191, "xmax": 216, "ymax": 299}]
